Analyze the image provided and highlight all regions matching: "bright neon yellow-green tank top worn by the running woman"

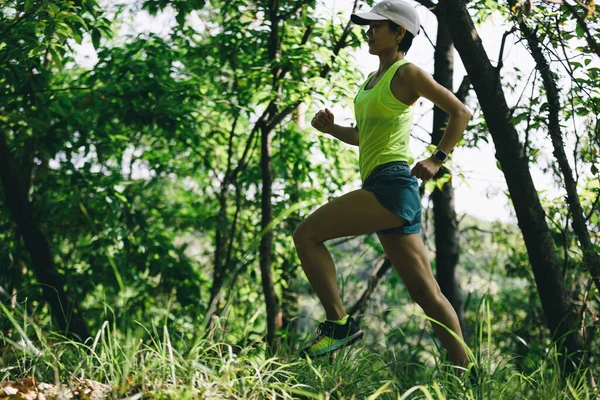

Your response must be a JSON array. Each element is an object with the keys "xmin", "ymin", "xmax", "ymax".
[{"xmin": 354, "ymin": 60, "xmax": 414, "ymax": 182}]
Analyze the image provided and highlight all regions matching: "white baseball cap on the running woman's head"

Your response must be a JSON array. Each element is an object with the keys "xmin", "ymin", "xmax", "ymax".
[{"xmin": 350, "ymin": 0, "xmax": 421, "ymax": 36}]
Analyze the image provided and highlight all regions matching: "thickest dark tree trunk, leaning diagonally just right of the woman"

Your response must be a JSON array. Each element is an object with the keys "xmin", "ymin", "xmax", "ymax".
[{"xmin": 437, "ymin": 0, "xmax": 583, "ymax": 373}]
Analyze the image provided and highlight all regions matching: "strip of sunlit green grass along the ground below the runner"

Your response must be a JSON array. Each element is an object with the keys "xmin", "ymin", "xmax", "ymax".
[{"xmin": 0, "ymin": 303, "xmax": 600, "ymax": 400}]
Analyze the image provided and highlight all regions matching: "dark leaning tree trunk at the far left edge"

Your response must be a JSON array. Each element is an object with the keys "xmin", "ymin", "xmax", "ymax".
[{"xmin": 0, "ymin": 131, "xmax": 90, "ymax": 341}]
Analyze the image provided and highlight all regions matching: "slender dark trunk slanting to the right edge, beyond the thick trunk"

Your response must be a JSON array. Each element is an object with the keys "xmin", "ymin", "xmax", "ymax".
[{"xmin": 519, "ymin": 21, "xmax": 600, "ymax": 291}]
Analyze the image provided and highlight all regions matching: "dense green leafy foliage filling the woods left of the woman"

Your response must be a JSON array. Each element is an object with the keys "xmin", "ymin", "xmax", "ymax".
[{"xmin": 0, "ymin": 1, "xmax": 368, "ymax": 334}]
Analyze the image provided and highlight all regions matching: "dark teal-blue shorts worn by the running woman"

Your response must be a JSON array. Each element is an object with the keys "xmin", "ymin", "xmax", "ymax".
[{"xmin": 362, "ymin": 161, "xmax": 421, "ymax": 235}]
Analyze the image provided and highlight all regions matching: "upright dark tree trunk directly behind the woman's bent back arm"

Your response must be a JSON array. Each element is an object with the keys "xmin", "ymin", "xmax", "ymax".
[{"xmin": 431, "ymin": 13, "xmax": 467, "ymax": 337}]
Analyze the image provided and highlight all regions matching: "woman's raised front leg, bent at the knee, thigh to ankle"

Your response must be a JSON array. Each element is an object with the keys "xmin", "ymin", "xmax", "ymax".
[{"xmin": 293, "ymin": 189, "xmax": 405, "ymax": 320}]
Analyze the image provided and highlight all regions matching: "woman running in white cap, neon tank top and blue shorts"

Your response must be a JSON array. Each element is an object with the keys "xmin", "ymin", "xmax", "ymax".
[{"xmin": 293, "ymin": 0, "xmax": 471, "ymax": 366}]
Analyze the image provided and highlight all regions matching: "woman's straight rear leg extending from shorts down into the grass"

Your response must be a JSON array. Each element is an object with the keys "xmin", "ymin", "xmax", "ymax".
[{"xmin": 378, "ymin": 233, "xmax": 469, "ymax": 367}]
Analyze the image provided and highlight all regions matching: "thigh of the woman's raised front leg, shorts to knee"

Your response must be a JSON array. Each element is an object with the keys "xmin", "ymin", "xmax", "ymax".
[{"xmin": 294, "ymin": 189, "xmax": 406, "ymax": 244}]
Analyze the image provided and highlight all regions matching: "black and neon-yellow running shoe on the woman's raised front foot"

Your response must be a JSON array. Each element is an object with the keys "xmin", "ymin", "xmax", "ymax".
[{"xmin": 300, "ymin": 316, "xmax": 364, "ymax": 358}]
